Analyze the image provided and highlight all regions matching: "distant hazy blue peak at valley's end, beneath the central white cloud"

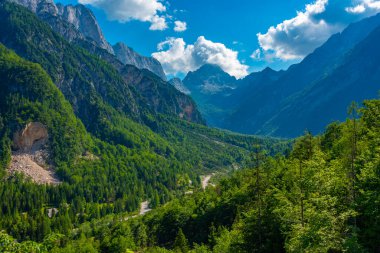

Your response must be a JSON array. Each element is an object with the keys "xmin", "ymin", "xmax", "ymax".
[{"xmin": 183, "ymin": 65, "xmax": 284, "ymax": 129}]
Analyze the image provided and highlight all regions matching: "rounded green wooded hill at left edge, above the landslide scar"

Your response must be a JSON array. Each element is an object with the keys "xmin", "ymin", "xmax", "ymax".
[{"xmin": 0, "ymin": 44, "xmax": 88, "ymax": 167}]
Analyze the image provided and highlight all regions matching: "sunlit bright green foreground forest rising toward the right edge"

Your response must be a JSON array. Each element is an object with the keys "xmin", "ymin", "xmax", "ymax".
[{"xmin": 0, "ymin": 97, "xmax": 380, "ymax": 253}]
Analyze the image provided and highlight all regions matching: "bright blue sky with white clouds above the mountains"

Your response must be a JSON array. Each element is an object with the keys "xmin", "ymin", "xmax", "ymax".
[{"xmin": 56, "ymin": 0, "xmax": 380, "ymax": 78}]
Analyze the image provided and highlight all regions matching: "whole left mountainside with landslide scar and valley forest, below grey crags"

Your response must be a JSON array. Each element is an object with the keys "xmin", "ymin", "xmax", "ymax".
[{"xmin": 0, "ymin": 1, "xmax": 288, "ymax": 244}]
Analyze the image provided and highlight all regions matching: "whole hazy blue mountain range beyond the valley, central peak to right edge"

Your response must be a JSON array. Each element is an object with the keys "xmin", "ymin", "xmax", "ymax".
[{"xmin": 177, "ymin": 14, "xmax": 380, "ymax": 137}]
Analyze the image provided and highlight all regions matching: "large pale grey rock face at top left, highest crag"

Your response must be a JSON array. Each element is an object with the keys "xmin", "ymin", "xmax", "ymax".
[{"xmin": 9, "ymin": 0, "xmax": 113, "ymax": 53}]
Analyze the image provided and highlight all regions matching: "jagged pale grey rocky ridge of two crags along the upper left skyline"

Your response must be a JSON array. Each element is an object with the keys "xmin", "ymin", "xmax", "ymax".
[{"xmin": 8, "ymin": 0, "xmax": 166, "ymax": 81}]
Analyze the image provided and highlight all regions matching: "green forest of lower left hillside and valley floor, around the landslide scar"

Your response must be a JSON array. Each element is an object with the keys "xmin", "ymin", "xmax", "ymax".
[{"xmin": 0, "ymin": 39, "xmax": 288, "ymax": 251}]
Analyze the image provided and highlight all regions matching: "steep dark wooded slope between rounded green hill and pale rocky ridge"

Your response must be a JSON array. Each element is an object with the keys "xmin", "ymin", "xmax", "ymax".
[{"xmin": 0, "ymin": 3, "xmax": 202, "ymax": 138}]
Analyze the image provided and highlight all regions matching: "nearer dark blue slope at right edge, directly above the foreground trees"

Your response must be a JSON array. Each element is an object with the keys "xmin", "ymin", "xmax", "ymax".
[{"xmin": 262, "ymin": 26, "xmax": 380, "ymax": 136}]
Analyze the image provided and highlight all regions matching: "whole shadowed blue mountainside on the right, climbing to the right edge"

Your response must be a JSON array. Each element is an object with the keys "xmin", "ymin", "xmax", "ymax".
[{"xmin": 228, "ymin": 15, "xmax": 380, "ymax": 137}]
